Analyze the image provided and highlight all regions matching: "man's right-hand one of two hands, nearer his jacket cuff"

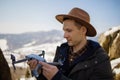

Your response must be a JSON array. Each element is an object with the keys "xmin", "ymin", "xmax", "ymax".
[{"xmin": 39, "ymin": 61, "xmax": 58, "ymax": 80}]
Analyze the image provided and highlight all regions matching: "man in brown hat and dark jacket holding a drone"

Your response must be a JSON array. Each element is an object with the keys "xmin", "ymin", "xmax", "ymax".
[{"xmin": 28, "ymin": 8, "xmax": 113, "ymax": 80}]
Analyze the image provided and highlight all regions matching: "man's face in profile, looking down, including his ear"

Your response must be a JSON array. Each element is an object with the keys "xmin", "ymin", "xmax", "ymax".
[{"xmin": 63, "ymin": 20, "xmax": 85, "ymax": 46}]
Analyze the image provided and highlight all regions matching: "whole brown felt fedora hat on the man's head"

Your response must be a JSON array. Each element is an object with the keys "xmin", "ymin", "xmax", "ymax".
[{"xmin": 56, "ymin": 8, "xmax": 97, "ymax": 37}]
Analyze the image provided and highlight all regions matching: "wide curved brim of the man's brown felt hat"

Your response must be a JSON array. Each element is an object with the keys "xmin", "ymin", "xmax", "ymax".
[{"xmin": 56, "ymin": 14, "xmax": 97, "ymax": 37}]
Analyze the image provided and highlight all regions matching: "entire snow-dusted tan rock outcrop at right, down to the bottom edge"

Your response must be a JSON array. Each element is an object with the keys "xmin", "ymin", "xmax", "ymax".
[{"xmin": 98, "ymin": 26, "xmax": 120, "ymax": 80}]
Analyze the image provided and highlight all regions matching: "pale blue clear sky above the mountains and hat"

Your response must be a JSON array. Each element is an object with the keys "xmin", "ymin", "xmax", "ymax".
[{"xmin": 0, "ymin": 0, "xmax": 120, "ymax": 34}]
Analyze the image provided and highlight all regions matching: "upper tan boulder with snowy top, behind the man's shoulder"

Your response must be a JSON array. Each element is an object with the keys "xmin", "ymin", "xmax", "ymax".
[{"xmin": 98, "ymin": 26, "xmax": 120, "ymax": 59}]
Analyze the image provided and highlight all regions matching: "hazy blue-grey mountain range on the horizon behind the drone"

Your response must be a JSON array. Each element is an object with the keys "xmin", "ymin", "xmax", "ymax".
[{"xmin": 0, "ymin": 30, "xmax": 63, "ymax": 49}]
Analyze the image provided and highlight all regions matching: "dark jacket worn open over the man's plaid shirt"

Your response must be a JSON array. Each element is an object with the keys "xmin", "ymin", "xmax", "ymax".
[{"xmin": 36, "ymin": 40, "xmax": 113, "ymax": 80}]
